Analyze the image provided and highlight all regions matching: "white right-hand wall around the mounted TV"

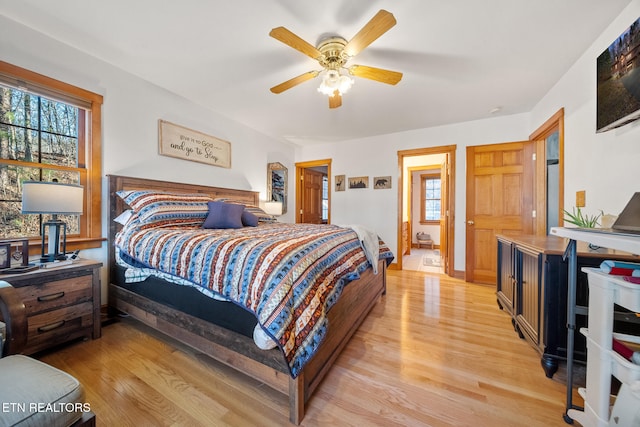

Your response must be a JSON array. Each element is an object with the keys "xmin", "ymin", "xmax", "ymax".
[{"xmin": 529, "ymin": 0, "xmax": 640, "ymax": 219}]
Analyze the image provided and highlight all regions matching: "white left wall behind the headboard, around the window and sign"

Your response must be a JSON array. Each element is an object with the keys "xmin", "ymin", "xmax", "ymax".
[{"xmin": 0, "ymin": 16, "xmax": 294, "ymax": 301}]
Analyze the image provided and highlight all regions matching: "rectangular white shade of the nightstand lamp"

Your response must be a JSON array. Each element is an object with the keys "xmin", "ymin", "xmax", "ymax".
[{"xmin": 22, "ymin": 181, "xmax": 84, "ymax": 215}]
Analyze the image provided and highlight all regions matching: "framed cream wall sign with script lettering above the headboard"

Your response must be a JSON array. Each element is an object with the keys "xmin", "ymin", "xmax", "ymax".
[{"xmin": 158, "ymin": 120, "xmax": 231, "ymax": 168}]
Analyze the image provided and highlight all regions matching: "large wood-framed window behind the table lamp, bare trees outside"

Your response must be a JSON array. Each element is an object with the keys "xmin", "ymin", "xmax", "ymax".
[{"xmin": 0, "ymin": 61, "xmax": 102, "ymax": 252}]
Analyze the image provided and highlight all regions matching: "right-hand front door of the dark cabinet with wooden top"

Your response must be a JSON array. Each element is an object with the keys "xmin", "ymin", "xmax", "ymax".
[{"xmin": 515, "ymin": 247, "xmax": 542, "ymax": 347}]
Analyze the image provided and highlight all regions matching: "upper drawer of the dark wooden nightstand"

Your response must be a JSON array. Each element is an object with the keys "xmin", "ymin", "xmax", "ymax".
[{"xmin": 17, "ymin": 275, "xmax": 92, "ymax": 316}]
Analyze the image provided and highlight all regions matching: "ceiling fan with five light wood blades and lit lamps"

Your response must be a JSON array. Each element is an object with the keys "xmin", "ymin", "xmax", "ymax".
[{"xmin": 269, "ymin": 9, "xmax": 402, "ymax": 108}]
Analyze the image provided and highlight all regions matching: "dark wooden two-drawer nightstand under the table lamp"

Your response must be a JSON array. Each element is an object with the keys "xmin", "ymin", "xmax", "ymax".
[{"xmin": 0, "ymin": 259, "xmax": 102, "ymax": 354}]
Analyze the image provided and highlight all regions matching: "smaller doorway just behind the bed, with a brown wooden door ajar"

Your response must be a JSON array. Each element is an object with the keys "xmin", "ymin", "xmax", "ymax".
[{"xmin": 295, "ymin": 159, "xmax": 331, "ymax": 224}]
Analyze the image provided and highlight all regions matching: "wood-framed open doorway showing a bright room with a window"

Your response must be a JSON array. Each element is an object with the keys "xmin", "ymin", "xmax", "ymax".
[{"xmin": 396, "ymin": 145, "xmax": 456, "ymax": 276}]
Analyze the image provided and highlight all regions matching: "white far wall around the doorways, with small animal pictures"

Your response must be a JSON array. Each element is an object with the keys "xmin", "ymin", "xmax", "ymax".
[{"xmin": 296, "ymin": 114, "xmax": 530, "ymax": 270}]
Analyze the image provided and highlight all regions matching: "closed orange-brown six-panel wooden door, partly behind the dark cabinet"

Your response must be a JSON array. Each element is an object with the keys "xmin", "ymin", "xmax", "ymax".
[{"xmin": 465, "ymin": 141, "xmax": 535, "ymax": 284}]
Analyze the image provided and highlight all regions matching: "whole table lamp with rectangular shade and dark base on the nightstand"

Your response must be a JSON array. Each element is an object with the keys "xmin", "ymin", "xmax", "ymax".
[{"xmin": 22, "ymin": 181, "xmax": 84, "ymax": 262}]
